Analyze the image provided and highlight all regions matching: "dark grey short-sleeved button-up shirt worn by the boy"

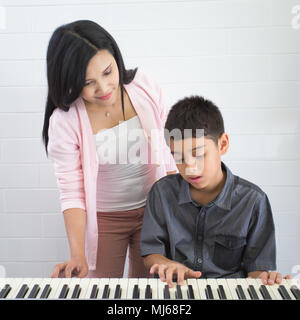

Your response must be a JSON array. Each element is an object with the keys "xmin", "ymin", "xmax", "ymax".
[{"xmin": 141, "ymin": 163, "xmax": 276, "ymax": 278}]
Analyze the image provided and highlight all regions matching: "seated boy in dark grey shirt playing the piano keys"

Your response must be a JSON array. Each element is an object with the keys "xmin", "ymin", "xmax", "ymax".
[{"xmin": 141, "ymin": 96, "xmax": 290, "ymax": 287}]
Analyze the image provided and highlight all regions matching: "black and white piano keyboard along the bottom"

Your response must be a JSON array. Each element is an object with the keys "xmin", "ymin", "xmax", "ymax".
[{"xmin": 0, "ymin": 278, "xmax": 300, "ymax": 300}]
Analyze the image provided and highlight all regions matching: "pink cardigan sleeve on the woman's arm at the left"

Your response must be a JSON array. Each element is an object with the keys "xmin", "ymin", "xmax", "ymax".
[{"xmin": 48, "ymin": 109, "xmax": 86, "ymax": 212}]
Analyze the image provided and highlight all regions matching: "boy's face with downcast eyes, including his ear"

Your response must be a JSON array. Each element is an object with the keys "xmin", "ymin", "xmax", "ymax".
[{"xmin": 170, "ymin": 133, "xmax": 229, "ymax": 190}]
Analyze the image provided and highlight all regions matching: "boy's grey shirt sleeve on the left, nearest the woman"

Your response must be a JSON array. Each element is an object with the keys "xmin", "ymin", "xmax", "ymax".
[{"xmin": 140, "ymin": 184, "xmax": 169, "ymax": 257}]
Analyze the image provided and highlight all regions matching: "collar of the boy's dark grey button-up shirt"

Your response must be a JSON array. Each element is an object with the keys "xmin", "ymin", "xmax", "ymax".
[{"xmin": 178, "ymin": 162, "xmax": 234, "ymax": 210}]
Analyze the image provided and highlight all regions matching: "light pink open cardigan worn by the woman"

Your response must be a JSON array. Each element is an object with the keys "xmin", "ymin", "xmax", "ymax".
[{"xmin": 48, "ymin": 69, "xmax": 177, "ymax": 270}]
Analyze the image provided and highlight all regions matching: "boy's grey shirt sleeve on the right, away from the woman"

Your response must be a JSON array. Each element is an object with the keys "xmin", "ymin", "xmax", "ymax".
[{"xmin": 243, "ymin": 194, "xmax": 276, "ymax": 273}]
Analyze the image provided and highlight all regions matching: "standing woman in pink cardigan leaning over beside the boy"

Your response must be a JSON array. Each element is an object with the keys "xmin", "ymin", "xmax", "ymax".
[{"xmin": 43, "ymin": 20, "xmax": 177, "ymax": 278}]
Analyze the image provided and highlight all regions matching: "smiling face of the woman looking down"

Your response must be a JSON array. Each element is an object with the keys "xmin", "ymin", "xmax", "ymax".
[{"xmin": 81, "ymin": 49, "xmax": 119, "ymax": 106}]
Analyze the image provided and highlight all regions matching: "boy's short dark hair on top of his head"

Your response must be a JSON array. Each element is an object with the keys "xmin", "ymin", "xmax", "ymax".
[{"xmin": 165, "ymin": 96, "xmax": 225, "ymax": 144}]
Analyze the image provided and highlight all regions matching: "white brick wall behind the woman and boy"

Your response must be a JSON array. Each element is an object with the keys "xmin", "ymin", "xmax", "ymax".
[{"xmin": 0, "ymin": 0, "xmax": 300, "ymax": 277}]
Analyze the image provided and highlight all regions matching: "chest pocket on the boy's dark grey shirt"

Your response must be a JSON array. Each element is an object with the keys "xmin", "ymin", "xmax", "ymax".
[{"xmin": 213, "ymin": 235, "xmax": 246, "ymax": 270}]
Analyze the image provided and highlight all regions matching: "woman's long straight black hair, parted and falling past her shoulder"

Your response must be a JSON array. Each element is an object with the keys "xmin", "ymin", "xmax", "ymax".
[{"xmin": 42, "ymin": 20, "xmax": 137, "ymax": 154}]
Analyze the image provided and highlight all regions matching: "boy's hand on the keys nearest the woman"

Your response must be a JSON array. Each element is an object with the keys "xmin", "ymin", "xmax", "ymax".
[{"xmin": 150, "ymin": 261, "xmax": 201, "ymax": 288}]
